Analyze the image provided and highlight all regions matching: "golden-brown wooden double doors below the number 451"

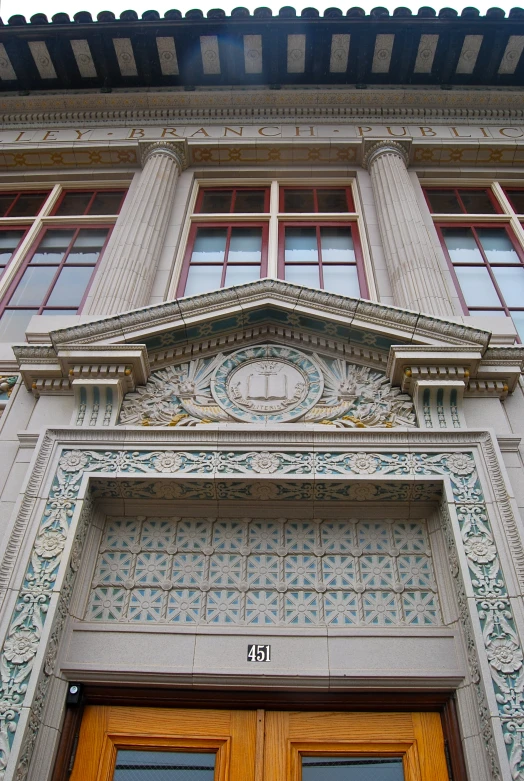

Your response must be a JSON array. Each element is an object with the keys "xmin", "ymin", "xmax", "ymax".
[{"xmin": 67, "ymin": 706, "xmax": 448, "ymax": 781}]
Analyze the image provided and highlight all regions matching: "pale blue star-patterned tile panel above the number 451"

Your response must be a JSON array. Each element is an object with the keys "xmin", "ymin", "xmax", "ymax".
[{"xmin": 86, "ymin": 517, "xmax": 441, "ymax": 626}]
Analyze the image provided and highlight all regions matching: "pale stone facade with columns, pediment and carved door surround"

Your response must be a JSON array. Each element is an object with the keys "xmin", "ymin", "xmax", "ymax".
[{"xmin": 0, "ymin": 15, "xmax": 524, "ymax": 781}]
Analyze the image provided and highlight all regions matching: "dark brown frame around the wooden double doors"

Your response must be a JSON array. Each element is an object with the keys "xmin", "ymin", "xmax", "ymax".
[{"xmin": 51, "ymin": 682, "xmax": 468, "ymax": 781}]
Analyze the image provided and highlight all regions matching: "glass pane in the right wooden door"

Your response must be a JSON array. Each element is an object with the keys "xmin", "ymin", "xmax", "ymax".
[{"xmin": 302, "ymin": 757, "xmax": 404, "ymax": 781}]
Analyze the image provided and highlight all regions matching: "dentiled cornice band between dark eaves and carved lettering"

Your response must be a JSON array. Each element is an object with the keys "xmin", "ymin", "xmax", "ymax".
[{"xmin": 0, "ymin": 88, "xmax": 524, "ymax": 127}]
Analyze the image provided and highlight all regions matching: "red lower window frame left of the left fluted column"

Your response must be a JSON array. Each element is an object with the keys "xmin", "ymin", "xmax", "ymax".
[{"xmin": 0, "ymin": 223, "xmax": 114, "ymax": 318}]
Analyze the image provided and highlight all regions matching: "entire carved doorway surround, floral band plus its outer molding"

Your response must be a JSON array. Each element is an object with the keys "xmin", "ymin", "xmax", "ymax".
[{"xmin": 0, "ymin": 429, "xmax": 524, "ymax": 781}]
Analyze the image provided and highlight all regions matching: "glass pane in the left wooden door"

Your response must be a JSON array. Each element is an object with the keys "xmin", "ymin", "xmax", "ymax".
[{"xmin": 113, "ymin": 750, "xmax": 215, "ymax": 781}]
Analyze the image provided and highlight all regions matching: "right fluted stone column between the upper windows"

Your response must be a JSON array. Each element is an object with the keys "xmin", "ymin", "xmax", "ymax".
[{"xmin": 364, "ymin": 141, "xmax": 455, "ymax": 317}]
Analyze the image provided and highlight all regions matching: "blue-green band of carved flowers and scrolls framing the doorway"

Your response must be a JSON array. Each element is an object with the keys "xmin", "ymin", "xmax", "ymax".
[{"xmin": 0, "ymin": 448, "xmax": 524, "ymax": 781}]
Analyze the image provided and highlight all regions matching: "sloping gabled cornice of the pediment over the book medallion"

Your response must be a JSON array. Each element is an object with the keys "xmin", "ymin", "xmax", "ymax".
[{"xmin": 45, "ymin": 279, "xmax": 490, "ymax": 353}]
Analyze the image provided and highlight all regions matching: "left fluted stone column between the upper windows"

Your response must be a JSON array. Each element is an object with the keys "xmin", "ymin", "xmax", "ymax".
[{"xmin": 82, "ymin": 140, "xmax": 187, "ymax": 315}]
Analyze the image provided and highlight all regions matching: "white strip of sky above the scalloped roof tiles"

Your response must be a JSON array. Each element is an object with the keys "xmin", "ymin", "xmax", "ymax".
[{"xmin": 0, "ymin": 0, "xmax": 518, "ymax": 23}]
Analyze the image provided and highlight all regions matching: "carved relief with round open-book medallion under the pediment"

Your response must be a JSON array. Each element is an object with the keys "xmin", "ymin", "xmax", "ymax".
[{"xmin": 120, "ymin": 344, "xmax": 415, "ymax": 428}]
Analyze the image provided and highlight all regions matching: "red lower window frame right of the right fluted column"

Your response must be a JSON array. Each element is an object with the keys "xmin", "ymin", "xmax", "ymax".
[{"xmin": 435, "ymin": 220, "xmax": 524, "ymax": 330}]
